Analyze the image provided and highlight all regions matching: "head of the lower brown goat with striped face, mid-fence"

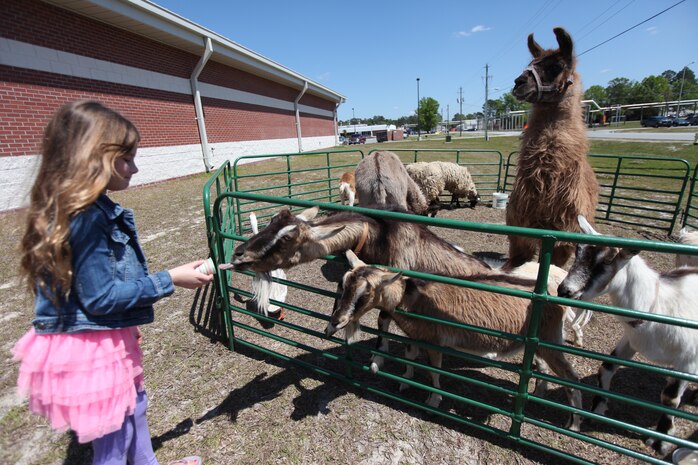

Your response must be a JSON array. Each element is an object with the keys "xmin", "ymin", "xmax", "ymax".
[{"xmin": 325, "ymin": 250, "xmax": 402, "ymax": 343}]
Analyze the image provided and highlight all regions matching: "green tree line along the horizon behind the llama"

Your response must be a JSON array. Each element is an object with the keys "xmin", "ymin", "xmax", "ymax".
[{"xmin": 339, "ymin": 66, "xmax": 698, "ymax": 131}]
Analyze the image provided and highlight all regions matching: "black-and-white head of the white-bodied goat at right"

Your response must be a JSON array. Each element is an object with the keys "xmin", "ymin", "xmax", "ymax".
[{"xmin": 557, "ymin": 215, "xmax": 639, "ymax": 300}]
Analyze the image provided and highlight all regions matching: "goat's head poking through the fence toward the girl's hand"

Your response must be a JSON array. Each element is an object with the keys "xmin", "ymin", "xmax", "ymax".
[{"xmin": 231, "ymin": 207, "xmax": 343, "ymax": 272}]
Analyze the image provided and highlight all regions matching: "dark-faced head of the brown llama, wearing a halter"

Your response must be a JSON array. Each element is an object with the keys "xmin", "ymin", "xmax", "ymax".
[{"xmin": 511, "ymin": 27, "xmax": 575, "ymax": 103}]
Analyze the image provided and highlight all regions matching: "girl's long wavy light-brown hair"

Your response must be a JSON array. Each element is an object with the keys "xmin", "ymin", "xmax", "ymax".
[{"xmin": 21, "ymin": 101, "xmax": 140, "ymax": 302}]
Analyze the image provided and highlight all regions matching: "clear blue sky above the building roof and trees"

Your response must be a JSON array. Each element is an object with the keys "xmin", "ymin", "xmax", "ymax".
[{"xmin": 155, "ymin": 0, "xmax": 698, "ymax": 120}]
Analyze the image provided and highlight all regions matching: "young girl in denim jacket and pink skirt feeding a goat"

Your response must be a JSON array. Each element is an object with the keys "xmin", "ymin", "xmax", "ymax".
[{"xmin": 13, "ymin": 101, "xmax": 212, "ymax": 465}]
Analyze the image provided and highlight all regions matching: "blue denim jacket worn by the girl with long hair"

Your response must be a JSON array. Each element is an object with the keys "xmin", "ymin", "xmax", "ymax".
[{"xmin": 33, "ymin": 195, "xmax": 174, "ymax": 333}]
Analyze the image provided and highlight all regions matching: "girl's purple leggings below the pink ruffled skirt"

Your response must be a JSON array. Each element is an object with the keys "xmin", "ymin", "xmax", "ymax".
[{"xmin": 92, "ymin": 391, "xmax": 158, "ymax": 465}]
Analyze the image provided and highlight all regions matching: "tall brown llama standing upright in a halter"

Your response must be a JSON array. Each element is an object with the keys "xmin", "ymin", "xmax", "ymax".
[{"xmin": 506, "ymin": 27, "xmax": 599, "ymax": 269}]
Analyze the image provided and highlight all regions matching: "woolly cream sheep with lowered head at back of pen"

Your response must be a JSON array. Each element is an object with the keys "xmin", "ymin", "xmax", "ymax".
[{"xmin": 405, "ymin": 161, "xmax": 480, "ymax": 214}]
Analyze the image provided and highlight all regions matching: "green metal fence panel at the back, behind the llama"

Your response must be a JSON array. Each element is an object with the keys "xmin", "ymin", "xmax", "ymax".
[{"xmin": 504, "ymin": 152, "xmax": 695, "ymax": 234}]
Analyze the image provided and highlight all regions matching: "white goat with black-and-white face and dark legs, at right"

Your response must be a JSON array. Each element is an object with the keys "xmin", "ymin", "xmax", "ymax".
[{"xmin": 558, "ymin": 215, "xmax": 698, "ymax": 454}]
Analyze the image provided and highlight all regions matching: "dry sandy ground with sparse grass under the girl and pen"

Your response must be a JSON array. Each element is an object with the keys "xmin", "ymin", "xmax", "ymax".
[{"xmin": 0, "ymin": 176, "xmax": 697, "ymax": 465}]
